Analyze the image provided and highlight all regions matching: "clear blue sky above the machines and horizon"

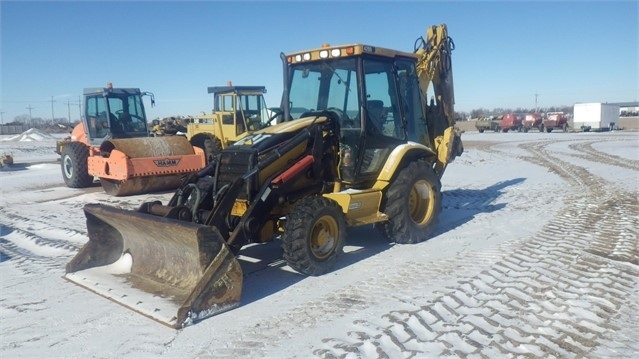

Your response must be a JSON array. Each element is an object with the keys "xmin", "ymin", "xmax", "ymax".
[{"xmin": 0, "ymin": 0, "xmax": 639, "ymax": 123}]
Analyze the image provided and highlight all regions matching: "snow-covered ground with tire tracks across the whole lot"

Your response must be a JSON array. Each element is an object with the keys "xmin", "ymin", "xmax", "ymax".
[{"xmin": 0, "ymin": 130, "xmax": 639, "ymax": 358}]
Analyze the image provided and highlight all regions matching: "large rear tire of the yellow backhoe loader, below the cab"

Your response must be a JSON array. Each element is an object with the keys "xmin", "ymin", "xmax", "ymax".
[{"xmin": 381, "ymin": 161, "xmax": 442, "ymax": 244}]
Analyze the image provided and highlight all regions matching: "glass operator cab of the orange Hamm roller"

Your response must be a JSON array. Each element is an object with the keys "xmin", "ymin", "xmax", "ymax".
[{"xmin": 84, "ymin": 86, "xmax": 155, "ymax": 145}]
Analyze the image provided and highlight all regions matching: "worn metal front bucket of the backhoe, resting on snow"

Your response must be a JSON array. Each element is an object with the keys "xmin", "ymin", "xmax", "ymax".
[{"xmin": 64, "ymin": 204, "xmax": 242, "ymax": 328}]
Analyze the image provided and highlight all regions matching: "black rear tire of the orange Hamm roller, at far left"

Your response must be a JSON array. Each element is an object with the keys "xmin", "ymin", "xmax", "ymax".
[{"xmin": 60, "ymin": 142, "xmax": 93, "ymax": 188}]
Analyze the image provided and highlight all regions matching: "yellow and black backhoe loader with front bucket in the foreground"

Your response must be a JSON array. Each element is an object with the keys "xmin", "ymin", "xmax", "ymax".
[{"xmin": 65, "ymin": 25, "xmax": 463, "ymax": 328}]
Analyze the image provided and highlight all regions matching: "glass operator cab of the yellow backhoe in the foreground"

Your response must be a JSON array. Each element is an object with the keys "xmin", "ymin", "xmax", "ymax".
[{"xmin": 283, "ymin": 45, "xmax": 429, "ymax": 187}]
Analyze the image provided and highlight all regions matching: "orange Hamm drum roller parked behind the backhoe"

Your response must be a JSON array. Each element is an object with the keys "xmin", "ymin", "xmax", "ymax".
[{"xmin": 56, "ymin": 83, "xmax": 205, "ymax": 196}]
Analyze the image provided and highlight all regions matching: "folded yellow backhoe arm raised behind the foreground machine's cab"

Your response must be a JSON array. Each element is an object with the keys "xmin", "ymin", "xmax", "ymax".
[{"xmin": 414, "ymin": 24, "xmax": 463, "ymax": 178}]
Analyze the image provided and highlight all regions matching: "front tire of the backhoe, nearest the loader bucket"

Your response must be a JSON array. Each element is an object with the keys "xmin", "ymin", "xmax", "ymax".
[{"xmin": 281, "ymin": 196, "xmax": 346, "ymax": 276}]
